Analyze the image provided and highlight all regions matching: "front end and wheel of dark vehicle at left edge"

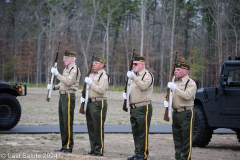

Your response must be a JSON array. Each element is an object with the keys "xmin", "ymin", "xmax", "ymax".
[{"xmin": 0, "ymin": 80, "xmax": 27, "ymax": 130}]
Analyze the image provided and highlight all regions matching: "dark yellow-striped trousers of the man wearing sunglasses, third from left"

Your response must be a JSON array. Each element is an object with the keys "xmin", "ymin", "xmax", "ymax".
[{"xmin": 130, "ymin": 104, "xmax": 152, "ymax": 159}]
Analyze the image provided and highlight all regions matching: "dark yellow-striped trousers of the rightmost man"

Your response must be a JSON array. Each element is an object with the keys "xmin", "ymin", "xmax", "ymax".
[{"xmin": 172, "ymin": 109, "xmax": 194, "ymax": 160}]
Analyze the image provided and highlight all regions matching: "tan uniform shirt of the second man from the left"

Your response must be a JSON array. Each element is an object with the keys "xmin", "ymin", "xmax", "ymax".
[{"xmin": 88, "ymin": 69, "xmax": 108, "ymax": 98}]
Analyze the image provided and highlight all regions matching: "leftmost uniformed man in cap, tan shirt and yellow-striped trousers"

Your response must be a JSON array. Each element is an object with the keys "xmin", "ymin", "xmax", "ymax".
[{"xmin": 51, "ymin": 51, "xmax": 81, "ymax": 153}]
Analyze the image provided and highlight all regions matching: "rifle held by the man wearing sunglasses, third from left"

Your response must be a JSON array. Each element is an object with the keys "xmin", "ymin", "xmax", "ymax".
[{"xmin": 123, "ymin": 48, "xmax": 135, "ymax": 112}]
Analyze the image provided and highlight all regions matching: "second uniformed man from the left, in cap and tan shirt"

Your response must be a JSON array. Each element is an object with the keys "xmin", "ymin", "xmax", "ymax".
[{"xmin": 81, "ymin": 55, "xmax": 109, "ymax": 156}]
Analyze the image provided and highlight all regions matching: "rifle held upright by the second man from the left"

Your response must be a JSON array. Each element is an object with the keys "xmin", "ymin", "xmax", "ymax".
[{"xmin": 79, "ymin": 52, "xmax": 95, "ymax": 114}]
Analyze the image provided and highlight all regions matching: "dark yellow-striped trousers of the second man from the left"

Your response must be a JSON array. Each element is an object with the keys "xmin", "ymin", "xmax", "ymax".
[{"xmin": 86, "ymin": 100, "xmax": 107, "ymax": 154}]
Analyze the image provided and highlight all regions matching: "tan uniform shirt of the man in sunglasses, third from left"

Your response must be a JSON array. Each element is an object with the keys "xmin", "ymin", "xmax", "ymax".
[{"xmin": 129, "ymin": 69, "xmax": 154, "ymax": 104}]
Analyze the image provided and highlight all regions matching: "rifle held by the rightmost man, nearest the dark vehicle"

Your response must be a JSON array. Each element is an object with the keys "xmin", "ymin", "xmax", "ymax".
[{"xmin": 163, "ymin": 52, "xmax": 177, "ymax": 121}]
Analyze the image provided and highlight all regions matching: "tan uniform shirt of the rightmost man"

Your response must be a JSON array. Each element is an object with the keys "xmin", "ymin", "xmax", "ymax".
[{"xmin": 172, "ymin": 75, "xmax": 197, "ymax": 109}]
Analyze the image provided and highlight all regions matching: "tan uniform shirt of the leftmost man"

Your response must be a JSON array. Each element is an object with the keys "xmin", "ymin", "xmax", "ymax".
[{"xmin": 55, "ymin": 62, "xmax": 81, "ymax": 91}]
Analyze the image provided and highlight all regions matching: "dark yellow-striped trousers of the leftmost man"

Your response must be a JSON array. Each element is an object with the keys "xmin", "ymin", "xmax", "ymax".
[{"xmin": 58, "ymin": 93, "xmax": 76, "ymax": 149}]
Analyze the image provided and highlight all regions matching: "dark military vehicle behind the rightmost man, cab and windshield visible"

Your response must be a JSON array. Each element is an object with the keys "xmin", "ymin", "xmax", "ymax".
[{"xmin": 193, "ymin": 57, "xmax": 240, "ymax": 147}]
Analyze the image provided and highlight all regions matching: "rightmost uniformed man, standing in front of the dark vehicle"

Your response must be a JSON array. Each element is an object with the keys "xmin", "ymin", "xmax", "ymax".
[{"xmin": 164, "ymin": 62, "xmax": 197, "ymax": 160}]
